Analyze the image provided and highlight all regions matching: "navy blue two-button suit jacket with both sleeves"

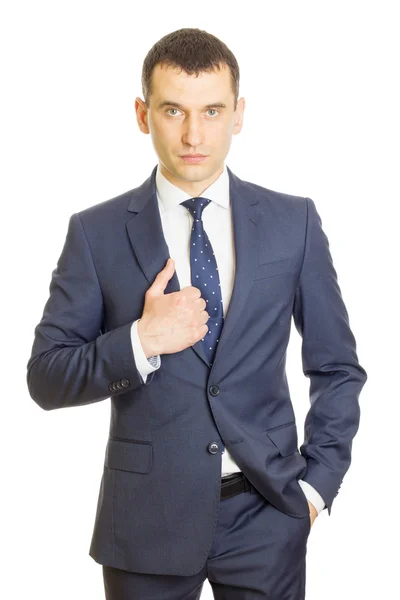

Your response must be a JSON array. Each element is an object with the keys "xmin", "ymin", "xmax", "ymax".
[{"xmin": 27, "ymin": 167, "xmax": 367, "ymax": 575}]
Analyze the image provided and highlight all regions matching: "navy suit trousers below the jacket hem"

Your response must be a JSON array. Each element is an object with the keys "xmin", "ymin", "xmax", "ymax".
[{"xmin": 103, "ymin": 484, "xmax": 311, "ymax": 600}]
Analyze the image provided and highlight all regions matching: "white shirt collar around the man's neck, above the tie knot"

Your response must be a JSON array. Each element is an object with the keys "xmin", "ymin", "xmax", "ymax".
[{"xmin": 156, "ymin": 164, "xmax": 229, "ymax": 212}]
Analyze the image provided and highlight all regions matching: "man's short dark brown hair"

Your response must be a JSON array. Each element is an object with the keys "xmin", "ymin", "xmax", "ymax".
[{"xmin": 142, "ymin": 27, "xmax": 239, "ymax": 110}]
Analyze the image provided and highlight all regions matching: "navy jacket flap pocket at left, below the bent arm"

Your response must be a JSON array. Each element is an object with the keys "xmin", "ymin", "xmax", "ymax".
[{"xmin": 105, "ymin": 438, "xmax": 153, "ymax": 473}]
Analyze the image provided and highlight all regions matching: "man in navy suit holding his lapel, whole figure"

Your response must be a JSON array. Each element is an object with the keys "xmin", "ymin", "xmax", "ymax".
[{"xmin": 27, "ymin": 29, "xmax": 367, "ymax": 600}]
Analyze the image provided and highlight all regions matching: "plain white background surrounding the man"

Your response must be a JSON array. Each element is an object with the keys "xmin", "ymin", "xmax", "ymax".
[{"xmin": 0, "ymin": 0, "xmax": 400, "ymax": 600}]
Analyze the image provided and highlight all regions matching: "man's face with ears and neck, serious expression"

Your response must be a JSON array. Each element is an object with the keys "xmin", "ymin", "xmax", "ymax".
[{"xmin": 135, "ymin": 65, "xmax": 244, "ymax": 196}]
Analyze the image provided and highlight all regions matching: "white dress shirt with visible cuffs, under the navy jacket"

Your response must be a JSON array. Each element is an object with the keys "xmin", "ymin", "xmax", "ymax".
[{"xmin": 131, "ymin": 165, "xmax": 325, "ymax": 513}]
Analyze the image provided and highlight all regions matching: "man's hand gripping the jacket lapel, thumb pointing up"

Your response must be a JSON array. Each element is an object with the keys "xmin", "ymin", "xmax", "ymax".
[{"xmin": 138, "ymin": 258, "xmax": 210, "ymax": 358}]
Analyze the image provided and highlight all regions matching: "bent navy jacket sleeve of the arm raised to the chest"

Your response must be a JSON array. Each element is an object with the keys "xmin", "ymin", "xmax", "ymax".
[{"xmin": 27, "ymin": 213, "xmax": 151, "ymax": 410}]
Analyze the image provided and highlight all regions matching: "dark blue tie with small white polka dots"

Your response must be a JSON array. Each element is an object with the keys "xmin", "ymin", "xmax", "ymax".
[{"xmin": 181, "ymin": 197, "xmax": 224, "ymax": 365}]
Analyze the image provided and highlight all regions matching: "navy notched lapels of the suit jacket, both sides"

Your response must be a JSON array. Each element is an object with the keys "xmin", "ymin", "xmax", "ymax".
[{"xmin": 126, "ymin": 166, "xmax": 258, "ymax": 367}]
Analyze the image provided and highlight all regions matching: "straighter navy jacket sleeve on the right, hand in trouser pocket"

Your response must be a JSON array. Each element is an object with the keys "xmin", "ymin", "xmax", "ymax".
[{"xmin": 293, "ymin": 198, "xmax": 367, "ymax": 515}]
